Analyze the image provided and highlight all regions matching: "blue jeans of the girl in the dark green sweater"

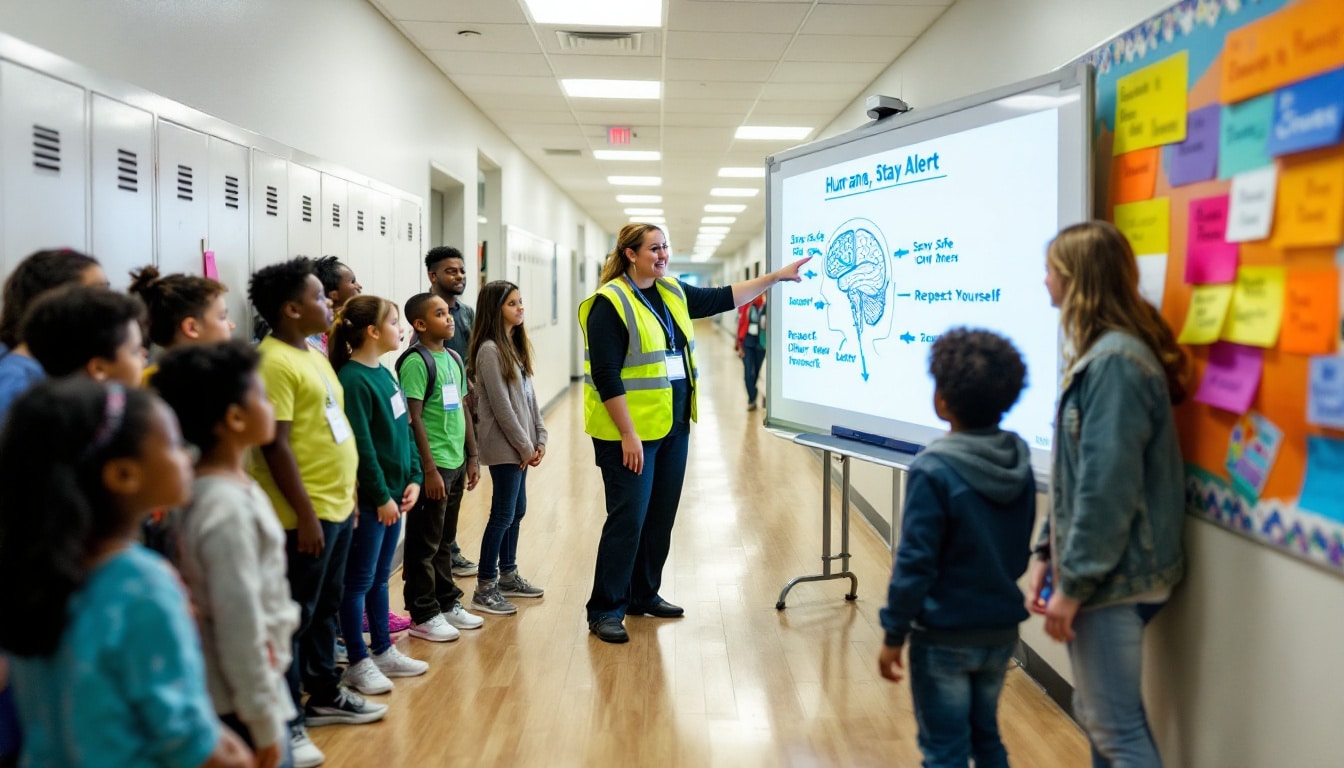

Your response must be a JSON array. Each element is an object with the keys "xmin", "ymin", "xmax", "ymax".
[{"xmin": 340, "ymin": 508, "xmax": 402, "ymax": 664}]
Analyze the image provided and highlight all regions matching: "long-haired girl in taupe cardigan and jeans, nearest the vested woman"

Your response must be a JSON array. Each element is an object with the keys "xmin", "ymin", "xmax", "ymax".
[{"xmin": 466, "ymin": 280, "xmax": 547, "ymax": 615}]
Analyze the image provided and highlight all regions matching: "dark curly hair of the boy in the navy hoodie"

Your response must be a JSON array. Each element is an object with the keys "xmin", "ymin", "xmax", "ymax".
[{"xmin": 929, "ymin": 328, "xmax": 1027, "ymax": 429}]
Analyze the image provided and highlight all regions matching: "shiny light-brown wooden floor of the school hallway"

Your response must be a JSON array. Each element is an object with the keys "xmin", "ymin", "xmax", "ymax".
[{"xmin": 312, "ymin": 323, "xmax": 1087, "ymax": 768}]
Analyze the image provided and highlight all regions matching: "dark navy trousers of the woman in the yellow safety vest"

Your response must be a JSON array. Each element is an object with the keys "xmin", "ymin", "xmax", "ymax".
[{"xmin": 587, "ymin": 424, "xmax": 691, "ymax": 623}]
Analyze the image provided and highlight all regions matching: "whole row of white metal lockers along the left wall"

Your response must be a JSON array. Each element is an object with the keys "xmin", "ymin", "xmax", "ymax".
[{"xmin": 0, "ymin": 59, "xmax": 423, "ymax": 330}]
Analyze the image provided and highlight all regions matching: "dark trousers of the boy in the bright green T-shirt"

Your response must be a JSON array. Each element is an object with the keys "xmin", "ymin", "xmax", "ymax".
[{"xmin": 402, "ymin": 467, "xmax": 466, "ymax": 624}]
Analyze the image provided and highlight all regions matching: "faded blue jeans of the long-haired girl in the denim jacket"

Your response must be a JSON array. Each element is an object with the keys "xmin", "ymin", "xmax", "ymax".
[{"xmin": 1068, "ymin": 604, "xmax": 1163, "ymax": 768}]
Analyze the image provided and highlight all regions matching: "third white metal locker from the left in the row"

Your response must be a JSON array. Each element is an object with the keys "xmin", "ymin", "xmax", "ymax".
[{"xmin": 159, "ymin": 120, "xmax": 210, "ymax": 274}]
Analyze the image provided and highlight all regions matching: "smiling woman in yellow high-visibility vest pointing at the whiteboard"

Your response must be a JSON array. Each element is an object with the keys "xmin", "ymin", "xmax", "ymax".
[{"xmin": 579, "ymin": 223, "xmax": 808, "ymax": 643}]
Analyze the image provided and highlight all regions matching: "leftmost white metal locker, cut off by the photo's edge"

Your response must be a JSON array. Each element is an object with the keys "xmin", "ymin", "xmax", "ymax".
[{"xmin": 0, "ymin": 61, "xmax": 89, "ymax": 274}]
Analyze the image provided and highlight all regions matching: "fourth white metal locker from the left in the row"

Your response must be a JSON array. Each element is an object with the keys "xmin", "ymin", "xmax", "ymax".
[{"xmin": 207, "ymin": 136, "xmax": 251, "ymax": 339}]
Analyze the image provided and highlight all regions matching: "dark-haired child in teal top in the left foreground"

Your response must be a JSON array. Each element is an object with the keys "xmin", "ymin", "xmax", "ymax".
[{"xmin": 0, "ymin": 377, "xmax": 253, "ymax": 768}]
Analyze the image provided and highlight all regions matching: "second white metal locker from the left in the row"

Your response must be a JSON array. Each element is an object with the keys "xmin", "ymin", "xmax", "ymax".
[{"xmin": 89, "ymin": 93, "xmax": 155, "ymax": 289}]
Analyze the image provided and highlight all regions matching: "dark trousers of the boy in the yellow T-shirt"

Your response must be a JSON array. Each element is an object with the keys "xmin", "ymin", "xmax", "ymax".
[{"xmin": 285, "ymin": 515, "xmax": 355, "ymax": 722}]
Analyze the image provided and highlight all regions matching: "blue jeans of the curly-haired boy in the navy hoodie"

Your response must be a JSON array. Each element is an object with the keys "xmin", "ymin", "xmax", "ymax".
[{"xmin": 910, "ymin": 643, "xmax": 1016, "ymax": 768}]
